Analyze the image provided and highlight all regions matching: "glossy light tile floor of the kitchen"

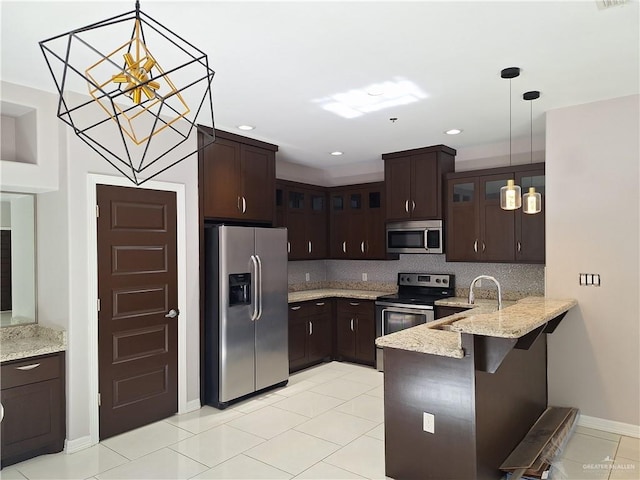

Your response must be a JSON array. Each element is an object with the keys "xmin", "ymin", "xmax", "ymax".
[{"xmin": 0, "ymin": 362, "xmax": 640, "ymax": 480}]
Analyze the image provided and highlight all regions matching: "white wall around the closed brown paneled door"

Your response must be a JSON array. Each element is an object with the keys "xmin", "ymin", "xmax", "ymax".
[{"xmin": 2, "ymin": 82, "xmax": 200, "ymax": 448}]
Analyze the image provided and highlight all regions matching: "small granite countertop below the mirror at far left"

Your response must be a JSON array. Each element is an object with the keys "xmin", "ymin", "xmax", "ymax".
[{"xmin": 0, "ymin": 324, "xmax": 67, "ymax": 362}]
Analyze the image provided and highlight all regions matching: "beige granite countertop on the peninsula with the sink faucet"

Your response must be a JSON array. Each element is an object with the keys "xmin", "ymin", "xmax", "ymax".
[{"xmin": 376, "ymin": 297, "xmax": 578, "ymax": 358}]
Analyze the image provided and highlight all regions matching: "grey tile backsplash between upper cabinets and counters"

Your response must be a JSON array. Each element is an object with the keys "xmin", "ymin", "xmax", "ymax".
[{"xmin": 289, "ymin": 255, "xmax": 544, "ymax": 298}]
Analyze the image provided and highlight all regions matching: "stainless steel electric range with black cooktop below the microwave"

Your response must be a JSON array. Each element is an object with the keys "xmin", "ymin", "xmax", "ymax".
[{"xmin": 376, "ymin": 273, "xmax": 456, "ymax": 371}]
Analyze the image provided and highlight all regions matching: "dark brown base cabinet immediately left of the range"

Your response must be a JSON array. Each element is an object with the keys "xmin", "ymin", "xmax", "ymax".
[{"xmin": 336, "ymin": 298, "xmax": 376, "ymax": 365}]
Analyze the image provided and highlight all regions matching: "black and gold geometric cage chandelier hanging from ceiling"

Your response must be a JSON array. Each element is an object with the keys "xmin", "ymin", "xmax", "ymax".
[{"xmin": 40, "ymin": 1, "xmax": 215, "ymax": 185}]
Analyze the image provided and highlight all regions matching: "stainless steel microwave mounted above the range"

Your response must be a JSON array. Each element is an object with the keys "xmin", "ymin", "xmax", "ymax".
[{"xmin": 387, "ymin": 220, "xmax": 444, "ymax": 253}]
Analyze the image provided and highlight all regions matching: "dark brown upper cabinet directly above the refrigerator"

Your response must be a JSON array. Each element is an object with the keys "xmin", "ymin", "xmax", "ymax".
[{"xmin": 198, "ymin": 127, "xmax": 278, "ymax": 224}]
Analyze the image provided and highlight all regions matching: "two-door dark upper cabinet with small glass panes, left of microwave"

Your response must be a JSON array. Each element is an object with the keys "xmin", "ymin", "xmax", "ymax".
[{"xmin": 329, "ymin": 182, "xmax": 387, "ymax": 260}]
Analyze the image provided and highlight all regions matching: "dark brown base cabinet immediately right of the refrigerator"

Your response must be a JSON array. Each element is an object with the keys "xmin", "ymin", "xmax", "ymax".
[{"xmin": 289, "ymin": 299, "xmax": 333, "ymax": 372}]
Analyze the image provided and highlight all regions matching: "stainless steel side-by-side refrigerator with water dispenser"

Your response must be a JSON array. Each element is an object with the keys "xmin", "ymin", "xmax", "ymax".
[{"xmin": 204, "ymin": 225, "xmax": 289, "ymax": 408}]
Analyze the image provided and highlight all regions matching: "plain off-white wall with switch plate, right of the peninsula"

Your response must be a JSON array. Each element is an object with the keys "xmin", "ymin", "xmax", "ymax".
[{"xmin": 546, "ymin": 95, "xmax": 640, "ymax": 428}]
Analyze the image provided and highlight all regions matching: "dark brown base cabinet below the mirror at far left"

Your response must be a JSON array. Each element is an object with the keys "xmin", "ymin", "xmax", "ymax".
[{"xmin": 0, "ymin": 352, "xmax": 66, "ymax": 467}]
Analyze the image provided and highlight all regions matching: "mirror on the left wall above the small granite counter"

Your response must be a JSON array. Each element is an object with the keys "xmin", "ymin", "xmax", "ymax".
[{"xmin": 0, "ymin": 192, "xmax": 36, "ymax": 327}]
